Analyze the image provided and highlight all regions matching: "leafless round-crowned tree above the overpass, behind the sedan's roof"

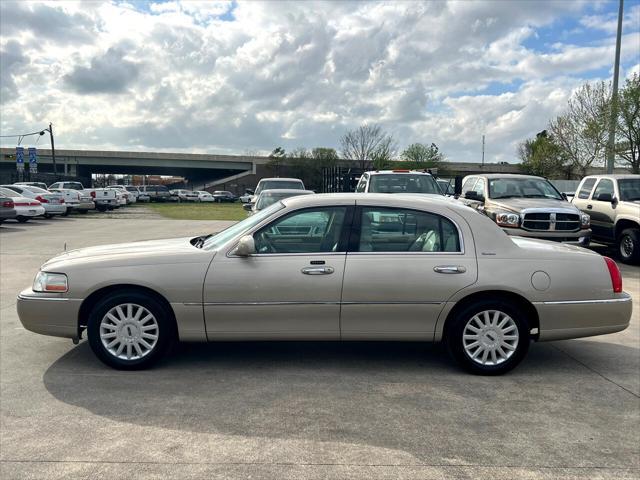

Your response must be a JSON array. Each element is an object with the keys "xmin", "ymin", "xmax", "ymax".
[{"xmin": 340, "ymin": 123, "xmax": 396, "ymax": 169}]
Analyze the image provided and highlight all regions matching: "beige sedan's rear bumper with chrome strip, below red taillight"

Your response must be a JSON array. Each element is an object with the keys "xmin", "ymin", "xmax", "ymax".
[{"xmin": 533, "ymin": 293, "xmax": 633, "ymax": 341}]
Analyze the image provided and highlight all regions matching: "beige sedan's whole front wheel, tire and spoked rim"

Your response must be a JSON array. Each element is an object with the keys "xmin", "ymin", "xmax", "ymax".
[{"xmin": 87, "ymin": 292, "xmax": 175, "ymax": 370}]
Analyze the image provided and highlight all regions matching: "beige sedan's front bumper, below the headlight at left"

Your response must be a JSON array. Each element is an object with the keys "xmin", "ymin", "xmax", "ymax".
[{"xmin": 16, "ymin": 288, "xmax": 82, "ymax": 338}]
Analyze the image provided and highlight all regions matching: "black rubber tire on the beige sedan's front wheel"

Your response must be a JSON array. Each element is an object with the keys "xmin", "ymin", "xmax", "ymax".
[{"xmin": 87, "ymin": 291, "xmax": 177, "ymax": 370}]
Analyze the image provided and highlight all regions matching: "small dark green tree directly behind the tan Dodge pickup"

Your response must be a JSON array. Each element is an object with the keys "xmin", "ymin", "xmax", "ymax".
[{"xmin": 518, "ymin": 130, "xmax": 566, "ymax": 177}]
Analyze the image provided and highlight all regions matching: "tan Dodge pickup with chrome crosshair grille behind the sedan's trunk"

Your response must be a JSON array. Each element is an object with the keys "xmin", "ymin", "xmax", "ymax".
[{"xmin": 460, "ymin": 173, "xmax": 591, "ymax": 247}]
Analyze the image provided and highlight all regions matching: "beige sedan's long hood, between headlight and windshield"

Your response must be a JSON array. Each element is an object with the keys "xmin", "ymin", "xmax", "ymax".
[{"xmin": 42, "ymin": 237, "xmax": 212, "ymax": 271}]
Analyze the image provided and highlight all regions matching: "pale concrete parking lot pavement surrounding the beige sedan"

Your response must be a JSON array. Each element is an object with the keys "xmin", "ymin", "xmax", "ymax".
[{"xmin": 0, "ymin": 217, "xmax": 640, "ymax": 479}]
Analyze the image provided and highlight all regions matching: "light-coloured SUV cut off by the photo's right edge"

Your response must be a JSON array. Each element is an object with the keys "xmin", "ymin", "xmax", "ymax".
[{"xmin": 572, "ymin": 175, "xmax": 640, "ymax": 265}]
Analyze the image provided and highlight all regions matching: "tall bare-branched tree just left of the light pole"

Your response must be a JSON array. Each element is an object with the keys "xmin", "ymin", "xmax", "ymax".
[{"xmin": 549, "ymin": 82, "xmax": 611, "ymax": 176}]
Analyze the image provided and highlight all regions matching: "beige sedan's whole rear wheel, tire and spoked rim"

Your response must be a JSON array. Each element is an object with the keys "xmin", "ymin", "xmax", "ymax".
[{"xmin": 446, "ymin": 300, "xmax": 530, "ymax": 375}]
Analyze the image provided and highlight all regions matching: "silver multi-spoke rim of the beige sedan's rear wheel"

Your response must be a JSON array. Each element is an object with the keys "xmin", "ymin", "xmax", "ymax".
[{"xmin": 462, "ymin": 310, "xmax": 518, "ymax": 365}]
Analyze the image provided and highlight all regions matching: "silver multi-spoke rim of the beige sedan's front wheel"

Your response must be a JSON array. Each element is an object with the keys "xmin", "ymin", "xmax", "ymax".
[{"xmin": 100, "ymin": 303, "xmax": 160, "ymax": 360}]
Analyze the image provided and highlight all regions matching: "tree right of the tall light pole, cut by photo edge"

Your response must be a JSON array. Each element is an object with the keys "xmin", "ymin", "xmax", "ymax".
[{"xmin": 616, "ymin": 73, "xmax": 640, "ymax": 173}]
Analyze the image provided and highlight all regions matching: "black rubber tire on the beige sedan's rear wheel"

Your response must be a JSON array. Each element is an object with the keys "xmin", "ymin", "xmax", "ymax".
[{"xmin": 445, "ymin": 299, "xmax": 531, "ymax": 375}]
